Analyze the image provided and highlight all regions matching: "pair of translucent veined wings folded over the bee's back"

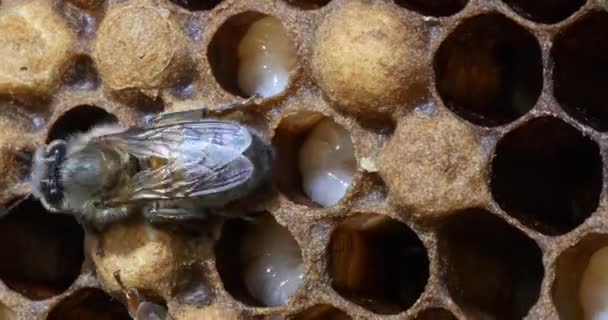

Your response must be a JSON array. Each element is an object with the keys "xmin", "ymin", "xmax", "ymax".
[{"xmin": 99, "ymin": 120, "xmax": 254, "ymax": 203}]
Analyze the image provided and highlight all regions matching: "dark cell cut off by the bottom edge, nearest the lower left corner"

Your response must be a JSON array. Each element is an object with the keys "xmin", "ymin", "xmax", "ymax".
[{"xmin": 46, "ymin": 288, "xmax": 131, "ymax": 320}]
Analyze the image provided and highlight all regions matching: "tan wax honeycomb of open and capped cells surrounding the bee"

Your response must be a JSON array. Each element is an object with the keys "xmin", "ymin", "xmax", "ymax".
[{"xmin": 0, "ymin": 0, "xmax": 608, "ymax": 320}]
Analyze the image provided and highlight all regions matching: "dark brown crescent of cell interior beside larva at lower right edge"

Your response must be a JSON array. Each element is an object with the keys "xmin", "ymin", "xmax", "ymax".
[{"xmin": 551, "ymin": 233, "xmax": 608, "ymax": 320}]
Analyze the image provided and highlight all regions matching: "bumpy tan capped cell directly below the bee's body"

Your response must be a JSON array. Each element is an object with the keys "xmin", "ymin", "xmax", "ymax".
[{"xmin": 87, "ymin": 220, "xmax": 194, "ymax": 298}]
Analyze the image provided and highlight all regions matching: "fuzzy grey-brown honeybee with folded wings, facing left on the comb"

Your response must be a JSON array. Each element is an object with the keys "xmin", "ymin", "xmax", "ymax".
[{"xmin": 31, "ymin": 101, "xmax": 274, "ymax": 229}]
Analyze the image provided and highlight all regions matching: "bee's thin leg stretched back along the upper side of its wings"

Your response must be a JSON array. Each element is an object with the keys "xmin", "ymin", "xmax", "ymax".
[{"xmin": 146, "ymin": 94, "xmax": 262, "ymax": 127}]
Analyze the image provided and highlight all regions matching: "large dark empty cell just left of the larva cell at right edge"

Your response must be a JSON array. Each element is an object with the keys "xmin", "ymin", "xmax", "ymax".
[{"xmin": 439, "ymin": 209, "xmax": 544, "ymax": 319}]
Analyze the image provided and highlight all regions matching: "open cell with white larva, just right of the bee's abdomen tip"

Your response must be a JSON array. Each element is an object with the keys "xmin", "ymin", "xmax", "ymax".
[{"xmin": 272, "ymin": 111, "xmax": 357, "ymax": 207}]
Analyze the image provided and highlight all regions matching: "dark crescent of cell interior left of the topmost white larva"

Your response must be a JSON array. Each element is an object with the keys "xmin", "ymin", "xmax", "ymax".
[{"xmin": 207, "ymin": 11, "xmax": 265, "ymax": 97}]
